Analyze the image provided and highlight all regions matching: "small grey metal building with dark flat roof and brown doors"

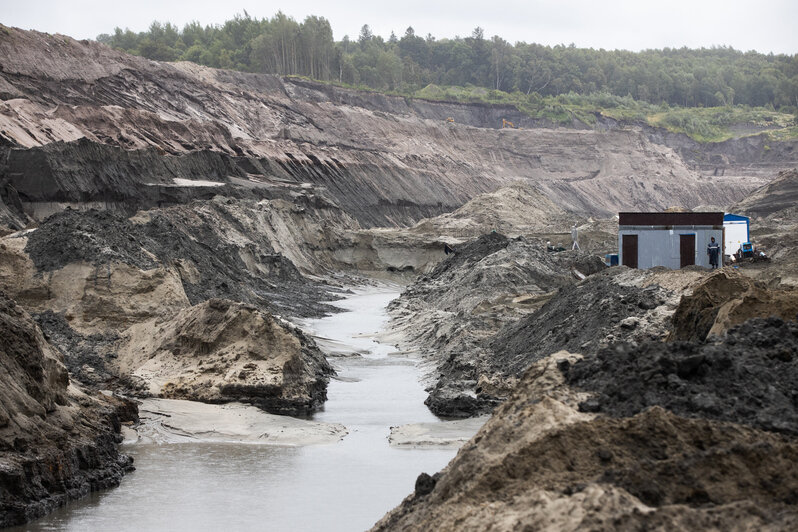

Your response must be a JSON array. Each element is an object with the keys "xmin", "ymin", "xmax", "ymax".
[{"xmin": 618, "ymin": 212, "xmax": 724, "ymax": 269}]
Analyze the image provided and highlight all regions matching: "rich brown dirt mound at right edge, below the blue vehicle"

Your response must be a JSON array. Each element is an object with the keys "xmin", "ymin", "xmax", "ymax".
[{"xmin": 669, "ymin": 268, "xmax": 798, "ymax": 342}]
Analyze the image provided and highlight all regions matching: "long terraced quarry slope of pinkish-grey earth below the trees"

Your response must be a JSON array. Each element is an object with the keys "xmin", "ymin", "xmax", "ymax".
[{"xmin": 0, "ymin": 27, "xmax": 790, "ymax": 230}]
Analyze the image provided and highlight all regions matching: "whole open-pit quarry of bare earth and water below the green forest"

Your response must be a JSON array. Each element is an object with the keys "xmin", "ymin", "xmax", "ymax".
[{"xmin": 0, "ymin": 26, "xmax": 798, "ymax": 531}]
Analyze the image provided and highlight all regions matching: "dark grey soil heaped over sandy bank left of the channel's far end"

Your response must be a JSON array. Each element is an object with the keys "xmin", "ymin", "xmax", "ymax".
[{"xmin": 25, "ymin": 206, "xmax": 333, "ymax": 317}]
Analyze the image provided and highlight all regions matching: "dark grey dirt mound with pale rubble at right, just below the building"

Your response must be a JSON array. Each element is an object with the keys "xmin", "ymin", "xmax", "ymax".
[{"xmin": 490, "ymin": 268, "xmax": 679, "ymax": 376}]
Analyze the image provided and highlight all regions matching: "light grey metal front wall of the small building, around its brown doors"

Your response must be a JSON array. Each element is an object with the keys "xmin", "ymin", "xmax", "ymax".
[{"xmin": 618, "ymin": 226, "xmax": 723, "ymax": 270}]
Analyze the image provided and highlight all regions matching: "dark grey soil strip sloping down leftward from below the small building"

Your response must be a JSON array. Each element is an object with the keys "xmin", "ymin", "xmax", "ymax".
[{"xmin": 490, "ymin": 268, "xmax": 664, "ymax": 375}]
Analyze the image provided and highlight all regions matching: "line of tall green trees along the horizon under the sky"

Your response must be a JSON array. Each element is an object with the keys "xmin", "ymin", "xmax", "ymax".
[{"xmin": 97, "ymin": 11, "xmax": 798, "ymax": 113}]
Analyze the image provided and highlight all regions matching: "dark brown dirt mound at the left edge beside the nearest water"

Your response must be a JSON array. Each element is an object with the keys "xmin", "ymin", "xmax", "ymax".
[{"xmin": 0, "ymin": 292, "xmax": 132, "ymax": 527}]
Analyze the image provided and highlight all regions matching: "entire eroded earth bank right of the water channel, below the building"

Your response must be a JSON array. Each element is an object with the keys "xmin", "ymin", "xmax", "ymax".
[{"xmin": 374, "ymin": 171, "xmax": 798, "ymax": 530}]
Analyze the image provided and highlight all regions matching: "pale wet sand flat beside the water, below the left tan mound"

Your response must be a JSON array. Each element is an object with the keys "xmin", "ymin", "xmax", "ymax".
[{"xmin": 125, "ymin": 399, "xmax": 347, "ymax": 447}]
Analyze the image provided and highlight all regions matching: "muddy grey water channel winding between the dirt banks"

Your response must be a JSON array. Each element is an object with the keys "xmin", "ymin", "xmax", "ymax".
[{"xmin": 25, "ymin": 287, "xmax": 456, "ymax": 531}]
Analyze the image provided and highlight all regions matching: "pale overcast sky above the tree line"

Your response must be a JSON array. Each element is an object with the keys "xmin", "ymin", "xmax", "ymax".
[{"xmin": 0, "ymin": 0, "xmax": 798, "ymax": 54}]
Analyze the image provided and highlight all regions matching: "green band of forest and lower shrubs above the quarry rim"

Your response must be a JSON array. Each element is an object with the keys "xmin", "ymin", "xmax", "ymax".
[{"xmin": 98, "ymin": 12, "xmax": 798, "ymax": 142}]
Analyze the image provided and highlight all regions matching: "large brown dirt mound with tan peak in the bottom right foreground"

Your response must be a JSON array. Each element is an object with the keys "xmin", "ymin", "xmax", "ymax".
[{"xmin": 374, "ymin": 391, "xmax": 798, "ymax": 530}]
